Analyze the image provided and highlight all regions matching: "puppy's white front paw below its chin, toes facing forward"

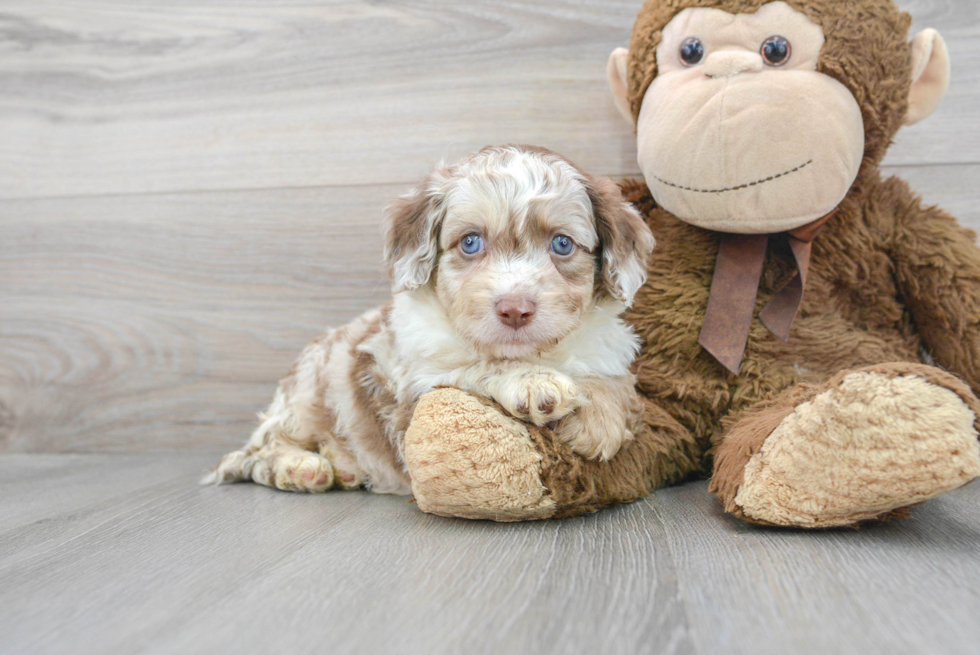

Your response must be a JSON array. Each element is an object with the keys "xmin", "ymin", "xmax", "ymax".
[{"xmin": 497, "ymin": 371, "xmax": 582, "ymax": 426}]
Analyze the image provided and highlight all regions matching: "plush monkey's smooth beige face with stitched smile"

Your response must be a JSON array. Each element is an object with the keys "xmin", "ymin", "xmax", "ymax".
[{"xmin": 637, "ymin": 2, "xmax": 865, "ymax": 234}]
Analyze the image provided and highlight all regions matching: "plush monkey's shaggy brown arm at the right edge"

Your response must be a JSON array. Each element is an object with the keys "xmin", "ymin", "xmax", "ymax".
[{"xmin": 878, "ymin": 178, "xmax": 980, "ymax": 392}]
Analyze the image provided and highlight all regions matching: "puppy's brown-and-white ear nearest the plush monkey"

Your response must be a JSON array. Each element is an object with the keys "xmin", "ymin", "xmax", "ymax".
[{"xmin": 587, "ymin": 177, "xmax": 656, "ymax": 307}]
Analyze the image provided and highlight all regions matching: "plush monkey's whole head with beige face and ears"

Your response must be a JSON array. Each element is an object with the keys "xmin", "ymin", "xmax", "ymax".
[{"xmin": 608, "ymin": 0, "xmax": 949, "ymax": 234}]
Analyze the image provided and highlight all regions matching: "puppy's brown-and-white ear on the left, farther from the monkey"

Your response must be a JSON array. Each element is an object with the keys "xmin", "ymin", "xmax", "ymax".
[{"xmin": 384, "ymin": 170, "xmax": 447, "ymax": 293}]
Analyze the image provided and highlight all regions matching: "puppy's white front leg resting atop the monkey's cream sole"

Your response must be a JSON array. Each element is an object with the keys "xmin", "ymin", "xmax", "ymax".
[{"xmin": 456, "ymin": 361, "xmax": 583, "ymax": 425}]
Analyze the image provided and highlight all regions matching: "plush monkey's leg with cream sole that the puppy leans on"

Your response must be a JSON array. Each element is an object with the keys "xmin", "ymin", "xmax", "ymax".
[{"xmin": 405, "ymin": 389, "xmax": 702, "ymax": 521}]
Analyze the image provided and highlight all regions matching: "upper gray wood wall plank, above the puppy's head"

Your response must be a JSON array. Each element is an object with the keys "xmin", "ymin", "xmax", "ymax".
[{"xmin": 0, "ymin": 0, "xmax": 980, "ymax": 198}]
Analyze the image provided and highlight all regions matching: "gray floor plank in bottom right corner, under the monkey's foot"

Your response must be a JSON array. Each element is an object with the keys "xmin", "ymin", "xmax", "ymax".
[{"xmin": 643, "ymin": 485, "xmax": 980, "ymax": 655}]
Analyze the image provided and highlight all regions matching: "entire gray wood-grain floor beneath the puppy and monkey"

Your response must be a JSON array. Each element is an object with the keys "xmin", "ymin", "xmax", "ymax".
[{"xmin": 0, "ymin": 453, "xmax": 980, "ymax": 655}]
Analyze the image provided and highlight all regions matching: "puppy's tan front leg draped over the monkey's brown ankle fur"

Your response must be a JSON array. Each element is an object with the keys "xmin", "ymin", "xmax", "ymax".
[{"xmin": 555, "ymin": 375, "xmax": 643, "ymax": 461}]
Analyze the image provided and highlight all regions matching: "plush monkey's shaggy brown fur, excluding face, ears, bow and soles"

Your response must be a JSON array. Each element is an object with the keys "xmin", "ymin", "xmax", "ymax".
[{"xmin": 402, "ymin": 0, "xmax": 980, "ymax": 527}]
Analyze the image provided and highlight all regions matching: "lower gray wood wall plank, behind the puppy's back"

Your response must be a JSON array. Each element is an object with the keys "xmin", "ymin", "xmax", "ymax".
[{"xmin": 0, "ymin": 165, "xmax": 980, "ymax": 452}]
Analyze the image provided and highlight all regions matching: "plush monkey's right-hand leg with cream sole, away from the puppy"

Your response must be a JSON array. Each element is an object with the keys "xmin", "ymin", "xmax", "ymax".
[{"xmin": 711, "ymin": 363, "xmax": 980, "ymax": 528}]
